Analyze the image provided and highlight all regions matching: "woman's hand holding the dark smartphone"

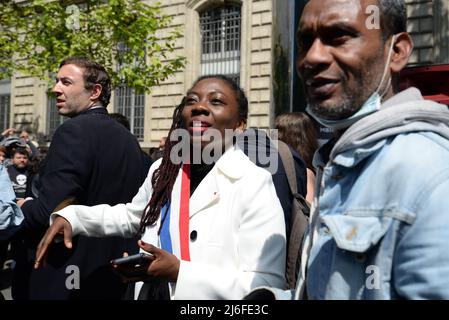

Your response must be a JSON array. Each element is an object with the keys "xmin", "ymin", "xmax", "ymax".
[{"xmin": 138, "ymin": 240, "xmax": 180, "ymax": 282}]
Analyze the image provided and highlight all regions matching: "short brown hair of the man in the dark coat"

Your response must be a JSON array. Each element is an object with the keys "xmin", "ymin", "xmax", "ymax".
[{"xmin": 59, "ymin": 57, "xmax": 111, "ymax": 107}]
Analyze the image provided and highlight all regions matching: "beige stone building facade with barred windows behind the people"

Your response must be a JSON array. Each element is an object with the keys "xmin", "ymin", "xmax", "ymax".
[{"xmin": 0, "ymin": 0, "xmax": 449, "ymax": 148}]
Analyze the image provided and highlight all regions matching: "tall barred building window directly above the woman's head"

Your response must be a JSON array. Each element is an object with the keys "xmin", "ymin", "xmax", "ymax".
[{"xmin": 200, "ymin": 6, "xmax": 241, "ymax": 83}]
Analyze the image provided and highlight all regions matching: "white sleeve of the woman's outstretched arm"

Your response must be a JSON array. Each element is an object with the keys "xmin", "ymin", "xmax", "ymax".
[{"xmin": 50, "ymin": 162, "xmax": 160, "ymax": 237}]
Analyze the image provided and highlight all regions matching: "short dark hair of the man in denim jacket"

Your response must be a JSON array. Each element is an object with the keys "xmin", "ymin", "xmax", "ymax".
[{"xmin": 378, "ymin": 0, "xmax": 407, "ymax": 40}]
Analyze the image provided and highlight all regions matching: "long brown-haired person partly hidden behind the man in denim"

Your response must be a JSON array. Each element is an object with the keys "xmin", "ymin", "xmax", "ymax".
[{"xmin": 275, "ymin": 112, "xmax": 319, "ymax": 203}]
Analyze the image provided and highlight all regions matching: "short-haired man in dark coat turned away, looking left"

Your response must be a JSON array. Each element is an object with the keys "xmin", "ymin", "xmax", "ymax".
[{"xmin": 13, "ymin": 57, "xmax": 145, "ymax": 299}]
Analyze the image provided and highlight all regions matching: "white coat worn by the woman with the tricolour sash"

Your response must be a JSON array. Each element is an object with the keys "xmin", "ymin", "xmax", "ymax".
[{"xmin": 53, "ymin": 147, "xmax": 286, "ymax": 299}]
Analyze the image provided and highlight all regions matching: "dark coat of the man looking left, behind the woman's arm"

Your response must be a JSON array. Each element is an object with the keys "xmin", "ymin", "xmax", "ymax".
[{"xmin": 17, "ymin": 108, "xmax": 146, "ymax": 299}]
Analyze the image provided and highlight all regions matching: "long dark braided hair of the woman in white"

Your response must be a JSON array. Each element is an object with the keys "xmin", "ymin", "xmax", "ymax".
[{"xmin": 139, "ymin": 75, "xmax": 248, "ymax": 234}]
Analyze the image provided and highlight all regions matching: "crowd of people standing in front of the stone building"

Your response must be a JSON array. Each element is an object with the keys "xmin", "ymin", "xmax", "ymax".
[{"xmin": 0, "ymin": 0, "xmax": 449, "ymax": 300}]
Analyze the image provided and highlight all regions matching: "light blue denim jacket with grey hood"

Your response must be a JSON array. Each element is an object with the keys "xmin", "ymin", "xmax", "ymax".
[{"xmin": 250, "ymin": 88, "xmax": 449, "ymax": 299}]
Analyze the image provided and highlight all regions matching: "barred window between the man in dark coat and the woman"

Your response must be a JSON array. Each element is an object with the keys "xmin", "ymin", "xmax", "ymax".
[{"xmin": 114, "ymin": 85, "xmax": 145, "ymax": 141}]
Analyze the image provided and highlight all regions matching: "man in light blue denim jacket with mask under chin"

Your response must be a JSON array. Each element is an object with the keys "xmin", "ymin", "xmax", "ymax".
[{"xmin": 248, "ymin": 0, "xmax": 449, "ymax": 299}]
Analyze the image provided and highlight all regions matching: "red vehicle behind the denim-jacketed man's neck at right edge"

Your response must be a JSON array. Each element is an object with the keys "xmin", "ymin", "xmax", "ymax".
[{"xmin": 400, "ymin": 64, "xmax": 449, "ymax": 106}]
